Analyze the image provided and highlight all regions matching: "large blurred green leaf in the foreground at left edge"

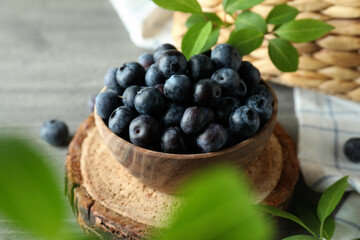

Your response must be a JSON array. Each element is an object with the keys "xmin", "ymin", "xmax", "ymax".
[{"xmin": 0, "ymin": 136, "xmax": 64, "ymax": 239}]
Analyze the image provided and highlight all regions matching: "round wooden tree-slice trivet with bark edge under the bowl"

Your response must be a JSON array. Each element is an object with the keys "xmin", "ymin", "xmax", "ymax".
[{"xmin": 65, "ymin": 115, "xmax": 298, "ymax": 239}]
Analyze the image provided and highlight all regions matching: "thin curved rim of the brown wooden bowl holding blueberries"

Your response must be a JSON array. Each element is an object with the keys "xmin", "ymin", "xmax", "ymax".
[{"xmin": 94, "ymin": 80, "xmax": 278, "ymax": 160}]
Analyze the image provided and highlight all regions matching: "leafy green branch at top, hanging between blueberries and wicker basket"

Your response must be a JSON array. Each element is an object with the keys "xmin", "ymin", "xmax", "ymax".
[{"xmin": 153, "ymin": 0, "xmax": 333, "ymax": 72}]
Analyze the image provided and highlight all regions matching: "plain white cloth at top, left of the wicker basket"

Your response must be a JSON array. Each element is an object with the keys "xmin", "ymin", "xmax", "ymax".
[{"xmin": 110, "ymin": 0, "xmax": 173, "ymax": 50}]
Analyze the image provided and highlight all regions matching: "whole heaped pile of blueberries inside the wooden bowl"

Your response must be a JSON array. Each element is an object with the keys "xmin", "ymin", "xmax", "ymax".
[{"xmin": 96, "ymin": 44, "xmax": 273, "ymax": 154}]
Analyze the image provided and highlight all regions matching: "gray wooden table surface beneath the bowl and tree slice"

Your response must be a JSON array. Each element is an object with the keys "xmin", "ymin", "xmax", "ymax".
[{"xmin": 0, "ymin": 0, "xmax": 297, "ymax": 239}]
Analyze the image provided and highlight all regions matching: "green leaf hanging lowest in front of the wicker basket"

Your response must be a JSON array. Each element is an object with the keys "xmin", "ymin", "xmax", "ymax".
[{"xmin": 269, "ymin": 38, "xmax": 299, "ymax": 72}]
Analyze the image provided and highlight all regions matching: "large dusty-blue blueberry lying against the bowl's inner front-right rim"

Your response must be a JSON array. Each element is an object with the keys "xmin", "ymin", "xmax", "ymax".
[{"xmin": 229, "ymin": 106, "xmax": 260, "ymax": 139}]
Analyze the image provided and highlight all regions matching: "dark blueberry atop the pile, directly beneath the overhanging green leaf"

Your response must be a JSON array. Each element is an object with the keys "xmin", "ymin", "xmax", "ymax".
[{"xmin": 188, "ymin": 54, "xmax": 214, "ymax": 81}]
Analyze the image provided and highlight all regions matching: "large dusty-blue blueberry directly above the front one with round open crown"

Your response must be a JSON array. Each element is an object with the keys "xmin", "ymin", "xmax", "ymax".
[{"xmin": 134, "ymin": 87, "xmax": 165, "ymax": 116}]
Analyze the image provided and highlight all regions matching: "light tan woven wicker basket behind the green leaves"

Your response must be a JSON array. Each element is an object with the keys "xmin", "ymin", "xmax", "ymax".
[{"xmin": 172, "ymin": 0, "xmax": 360, "ymax": 102}]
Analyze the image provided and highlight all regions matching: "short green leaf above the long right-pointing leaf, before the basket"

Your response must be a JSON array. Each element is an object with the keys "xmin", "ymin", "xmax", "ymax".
[{"xmin": 266, "ymin": 4, "xmax": 299, "ymax": 24}]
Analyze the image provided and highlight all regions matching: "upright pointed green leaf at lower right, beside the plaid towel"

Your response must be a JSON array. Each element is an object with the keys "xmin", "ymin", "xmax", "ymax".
[{"xmin": 317, "ymin": 176, "xmax": 348, "ymax": 225}]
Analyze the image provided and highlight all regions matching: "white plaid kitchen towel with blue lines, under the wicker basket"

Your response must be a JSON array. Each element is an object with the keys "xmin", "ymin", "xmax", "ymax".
[{"xmin": 294, "ymin": 88, "xmax": 360, "ymax": 240}]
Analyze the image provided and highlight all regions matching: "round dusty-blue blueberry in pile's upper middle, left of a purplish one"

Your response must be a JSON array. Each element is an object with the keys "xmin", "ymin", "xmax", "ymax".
[{"xmin": 164, "ymin": 75, "xmax": 192, "ymax": 103}]
